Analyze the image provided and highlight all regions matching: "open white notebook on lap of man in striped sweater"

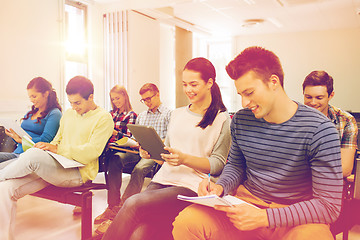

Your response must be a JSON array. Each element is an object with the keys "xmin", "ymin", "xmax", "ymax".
[{"xmin": 177, "ymin": 195, "xmax": 255, "ymax": 207}]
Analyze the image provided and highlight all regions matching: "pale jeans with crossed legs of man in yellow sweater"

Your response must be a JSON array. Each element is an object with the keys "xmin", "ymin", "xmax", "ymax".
[{"xmin": 0, "ymin": 148, "xmax": 83, "ymax": 240}]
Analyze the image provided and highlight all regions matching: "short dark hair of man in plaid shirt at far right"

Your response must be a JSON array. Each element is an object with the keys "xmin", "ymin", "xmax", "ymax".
[{"xmin": 303, "ymin": 71, "xmax": 334, "ymax": 96}]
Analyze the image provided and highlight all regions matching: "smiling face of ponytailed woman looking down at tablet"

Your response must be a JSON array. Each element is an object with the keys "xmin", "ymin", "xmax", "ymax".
[{"xmin": 183, "ymin": 69, "xmax": 213, "ymax": 104}]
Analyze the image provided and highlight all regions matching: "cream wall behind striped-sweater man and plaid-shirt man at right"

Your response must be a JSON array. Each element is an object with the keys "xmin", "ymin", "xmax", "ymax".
[{"xmin": 235, "ymin": 29, "xmax": 360, "ymax": 112}]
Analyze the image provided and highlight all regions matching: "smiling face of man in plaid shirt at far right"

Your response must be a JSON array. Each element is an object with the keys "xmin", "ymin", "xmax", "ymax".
[{"xmin": 304, "ymin": 86, "xmax": 334, "ymax": 116}]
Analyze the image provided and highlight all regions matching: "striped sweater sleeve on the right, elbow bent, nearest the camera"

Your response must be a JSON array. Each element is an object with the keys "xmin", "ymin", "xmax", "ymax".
[{"xmin": 266, "ymin": 122, "xmax": 343, "ymax": 228}]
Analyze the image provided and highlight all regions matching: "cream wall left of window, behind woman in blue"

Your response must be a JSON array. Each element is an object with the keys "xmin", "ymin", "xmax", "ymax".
[{"xmin": 0, "ymin": 0, "xmax": 62, "ymax": 117}]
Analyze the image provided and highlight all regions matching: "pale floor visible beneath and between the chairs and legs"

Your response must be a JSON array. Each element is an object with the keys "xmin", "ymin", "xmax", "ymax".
[{"xmin": 15, "ymin": 174, "xmax": 360, "ymax": 240}]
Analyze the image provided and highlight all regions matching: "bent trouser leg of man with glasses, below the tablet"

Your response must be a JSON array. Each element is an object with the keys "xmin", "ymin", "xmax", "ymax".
[{"xmin": 122, "ymin": 158, "xmax": 155, "ymax": 202}]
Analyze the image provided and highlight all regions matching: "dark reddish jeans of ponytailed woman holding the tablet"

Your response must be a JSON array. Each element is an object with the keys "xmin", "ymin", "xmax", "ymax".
[{"xmin": 103, "ymin": 182, "xmax": 197, "ymax": 240}]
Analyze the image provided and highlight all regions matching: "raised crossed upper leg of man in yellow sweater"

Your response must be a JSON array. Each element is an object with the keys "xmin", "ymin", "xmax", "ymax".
[{"xmin": 0, "ymin": 148, "xmax": 83, "ymax": 187}]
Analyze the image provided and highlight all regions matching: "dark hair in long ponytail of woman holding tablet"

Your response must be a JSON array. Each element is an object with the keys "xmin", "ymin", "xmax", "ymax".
[{"xmin": 184, "ymin": 57, "xmax": 226, "ymax": 129}]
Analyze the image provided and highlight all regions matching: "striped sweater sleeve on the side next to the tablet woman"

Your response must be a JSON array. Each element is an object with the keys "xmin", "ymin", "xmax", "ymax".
[{"xmin": 216, "ymin": 116, "xmax": 246, "ymax": 195}]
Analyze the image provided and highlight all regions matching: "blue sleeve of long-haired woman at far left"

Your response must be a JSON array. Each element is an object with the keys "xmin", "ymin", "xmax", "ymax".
[{"xmin": 32, "ymin": 108, "xmax": 62, "ymax": 143}]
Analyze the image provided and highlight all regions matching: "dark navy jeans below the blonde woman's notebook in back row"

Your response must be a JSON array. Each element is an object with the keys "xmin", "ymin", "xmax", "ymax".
[{"xmin": 106, "ymin": 152, "xmax": 140, "ymax": 208}]
